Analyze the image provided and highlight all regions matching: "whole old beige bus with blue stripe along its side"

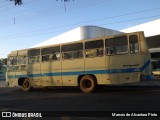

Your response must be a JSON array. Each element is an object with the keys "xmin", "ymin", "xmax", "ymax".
[{"xmin": 6, "ymin": 32, "xmax": 151, "ymax": 93}]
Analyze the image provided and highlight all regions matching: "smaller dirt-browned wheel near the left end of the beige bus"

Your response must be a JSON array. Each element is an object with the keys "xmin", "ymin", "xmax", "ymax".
[{"xmin": 21, "ymin": 78, "xmax": 32, "ymax": 92}]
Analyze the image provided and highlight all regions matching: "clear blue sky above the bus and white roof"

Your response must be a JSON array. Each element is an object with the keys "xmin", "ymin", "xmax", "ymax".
[{"xmin": 0, "ymin": 0, "xmax": 160, "ymax": 58}]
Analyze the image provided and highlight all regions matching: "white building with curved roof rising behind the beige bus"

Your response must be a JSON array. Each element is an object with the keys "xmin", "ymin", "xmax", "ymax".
[{"xmin": 33, "ymin": 19, "xmax": 160, "ymax": 48}]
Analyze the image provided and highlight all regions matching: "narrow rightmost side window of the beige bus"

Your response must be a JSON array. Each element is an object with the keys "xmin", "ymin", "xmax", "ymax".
[{"xmin": 129, "ymin": 35, "xmax": 139, "ymax": 54}]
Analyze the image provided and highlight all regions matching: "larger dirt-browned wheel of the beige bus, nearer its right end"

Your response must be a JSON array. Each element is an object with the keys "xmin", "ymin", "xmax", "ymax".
[{"xmin": 80, "ymin": 75, "xmax": 97, "ymax": 93}]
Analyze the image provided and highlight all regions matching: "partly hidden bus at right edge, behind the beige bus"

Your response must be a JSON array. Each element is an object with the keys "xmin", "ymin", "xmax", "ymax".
[{"xmin": 149, "ymin": 48, "xmax": 160, "ymax": 79}]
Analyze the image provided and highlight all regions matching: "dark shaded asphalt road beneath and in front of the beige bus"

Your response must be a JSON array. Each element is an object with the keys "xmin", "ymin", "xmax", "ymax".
[{"xmin": 0, "ymin": 81, "xmax": 160, "ymax": 120}]
